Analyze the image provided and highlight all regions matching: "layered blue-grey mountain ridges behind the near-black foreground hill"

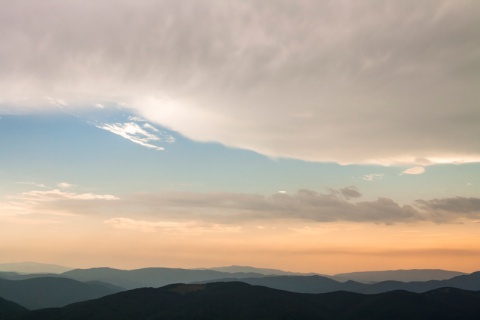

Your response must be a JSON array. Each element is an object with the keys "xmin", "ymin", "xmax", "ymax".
[{"xmin": 0, "ymin": 266, "xmax": 480, "ymax": 309}]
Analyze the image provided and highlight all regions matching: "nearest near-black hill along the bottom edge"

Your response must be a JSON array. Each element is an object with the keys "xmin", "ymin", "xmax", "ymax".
[{"xmin": 7, "ymin": 282, "xmax": 480, "ymax": 320}]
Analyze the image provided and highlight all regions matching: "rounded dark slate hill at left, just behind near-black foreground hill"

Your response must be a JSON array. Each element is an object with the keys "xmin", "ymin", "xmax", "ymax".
[{"xmin": 0, "ymin": 277, "xmax": 124, "ymax": 309}]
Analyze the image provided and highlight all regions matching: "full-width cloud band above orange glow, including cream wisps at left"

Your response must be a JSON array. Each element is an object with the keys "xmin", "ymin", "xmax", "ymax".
[{"xmin": 0, "ymin": 187, "xmax": 480, "ymax": 224}]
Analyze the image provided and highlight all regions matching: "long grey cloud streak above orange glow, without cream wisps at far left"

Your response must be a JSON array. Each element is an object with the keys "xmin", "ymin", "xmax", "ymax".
[{"xmin": 28, "ymin": 187, "xmax": 480, "ymax": 224}]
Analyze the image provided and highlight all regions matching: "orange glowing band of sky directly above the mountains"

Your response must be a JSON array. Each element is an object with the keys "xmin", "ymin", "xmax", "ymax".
[{"xmin": 0, "ymin": 221, "xmax": 480, "ymax": 274}]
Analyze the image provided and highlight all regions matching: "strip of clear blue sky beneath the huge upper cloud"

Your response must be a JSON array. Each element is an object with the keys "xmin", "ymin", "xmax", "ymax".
[{"xmin": 0, "ymin": 108, "xmax": 480, "ymax": 203}]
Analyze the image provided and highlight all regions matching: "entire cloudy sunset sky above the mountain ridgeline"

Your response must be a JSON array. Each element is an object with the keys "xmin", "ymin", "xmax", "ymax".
[{"xmin": 0, "ymin": 0, "xmax": 480, "ymax": 274}]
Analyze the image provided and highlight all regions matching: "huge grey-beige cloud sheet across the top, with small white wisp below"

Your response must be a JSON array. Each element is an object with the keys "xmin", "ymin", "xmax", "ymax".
[{"xmin": 0, "ymin": 0, "xmax": 480, "ymax": 165}]
